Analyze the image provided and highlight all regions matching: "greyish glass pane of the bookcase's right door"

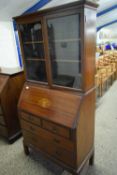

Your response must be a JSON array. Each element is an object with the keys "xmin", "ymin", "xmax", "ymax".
[{"xmin": 47, "ymin": 14, "xmax": 81, "ymax": 88}]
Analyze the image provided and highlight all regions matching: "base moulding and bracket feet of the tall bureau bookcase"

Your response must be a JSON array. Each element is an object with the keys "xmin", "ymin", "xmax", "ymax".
[{"xmin": 23, "ymin": 140, "xmax": 94, "ymax": 175}]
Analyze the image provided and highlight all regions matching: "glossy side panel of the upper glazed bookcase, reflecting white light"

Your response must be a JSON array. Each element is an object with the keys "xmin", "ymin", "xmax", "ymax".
[{"xmin": 82, "ymin": 8, "xmax": 96, "ymax": 92}]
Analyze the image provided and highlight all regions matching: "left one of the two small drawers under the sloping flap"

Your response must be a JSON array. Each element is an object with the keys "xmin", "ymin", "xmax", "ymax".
[{"xmin": 21, "ymin": 112, "xmax": 41, "ymax": 126}]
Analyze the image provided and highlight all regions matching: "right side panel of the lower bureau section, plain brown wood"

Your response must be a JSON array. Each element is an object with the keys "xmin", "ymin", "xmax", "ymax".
[{"xmin": 76, "ymin": 90, "xmax": 95, "ymax": 166}]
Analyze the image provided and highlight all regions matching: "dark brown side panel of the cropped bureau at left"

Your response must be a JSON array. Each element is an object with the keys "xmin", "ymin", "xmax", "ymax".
[{"xmin": 1, "ymin": 73, "xmax": 24, "ymax": 137}]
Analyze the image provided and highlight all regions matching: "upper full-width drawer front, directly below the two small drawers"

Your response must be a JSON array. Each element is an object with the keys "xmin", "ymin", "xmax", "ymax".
[{"xmin": 21, "ymin": 120, "xmax": 74, "ymax": 151}]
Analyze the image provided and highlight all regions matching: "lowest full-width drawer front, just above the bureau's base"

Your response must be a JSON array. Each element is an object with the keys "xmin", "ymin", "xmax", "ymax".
[{"xmin": 23, "ymin": 131, "xmax": 75, "ymax": 167}]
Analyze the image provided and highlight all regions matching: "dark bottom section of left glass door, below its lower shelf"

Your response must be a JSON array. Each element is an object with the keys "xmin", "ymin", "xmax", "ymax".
[{"xmin": 26, "ymin": 60, "xmax": 47, "ymax": 82}]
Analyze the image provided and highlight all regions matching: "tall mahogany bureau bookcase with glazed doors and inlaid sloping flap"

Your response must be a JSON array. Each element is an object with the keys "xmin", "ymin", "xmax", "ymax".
[{"xmin": 14, "ymin": 0, "xmax": 97, "ymax": 174}]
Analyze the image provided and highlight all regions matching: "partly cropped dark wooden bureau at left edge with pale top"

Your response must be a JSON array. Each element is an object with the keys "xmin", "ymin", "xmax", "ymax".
[{"xmin": 0, "ymin": 68, "xmax": 25, "ymax": 143}]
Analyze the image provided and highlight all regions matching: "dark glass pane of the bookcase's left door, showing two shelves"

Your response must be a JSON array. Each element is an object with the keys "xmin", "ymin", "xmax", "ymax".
[{"xmin": 19, "ymin": 21, "xmax": 47, "ymax": 82}]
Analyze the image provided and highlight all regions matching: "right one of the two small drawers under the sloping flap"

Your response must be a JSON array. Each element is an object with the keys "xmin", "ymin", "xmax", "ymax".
[{"xmin": 42, "ymin": 120, "xmax": 70, "ymax": 138}]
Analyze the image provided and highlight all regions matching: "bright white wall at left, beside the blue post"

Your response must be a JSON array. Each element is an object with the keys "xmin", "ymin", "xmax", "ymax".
[{"xmin": 0, "ymin": 21, "xmax": 19, "ymax": 67}]
